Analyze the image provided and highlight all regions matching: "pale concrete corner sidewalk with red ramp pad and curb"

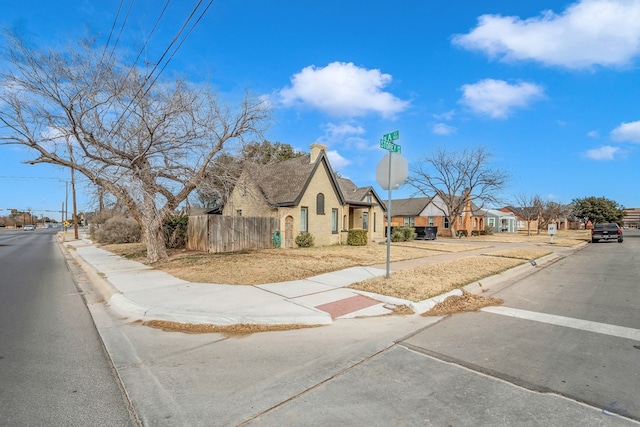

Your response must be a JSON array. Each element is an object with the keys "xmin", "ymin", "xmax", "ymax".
[{"xmin": 63, "ymin": 239, "xmax": 576, "ymax": 325}]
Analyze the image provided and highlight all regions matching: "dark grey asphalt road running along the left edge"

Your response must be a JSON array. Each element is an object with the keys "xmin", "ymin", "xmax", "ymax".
[{"xmin": 0, "ymin": 229, "xmax": 137, "ymax": 426}]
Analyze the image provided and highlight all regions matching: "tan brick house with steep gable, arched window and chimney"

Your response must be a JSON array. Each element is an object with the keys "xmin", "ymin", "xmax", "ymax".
[{"xmin": 222, "ymin": 144, "xmax": 385, "ymax": 247}]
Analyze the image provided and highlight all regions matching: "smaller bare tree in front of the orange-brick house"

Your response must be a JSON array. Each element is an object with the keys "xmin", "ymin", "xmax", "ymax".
[{"xmin": 407, "ymin": 147, "xmax": 509, "ymax": 237}]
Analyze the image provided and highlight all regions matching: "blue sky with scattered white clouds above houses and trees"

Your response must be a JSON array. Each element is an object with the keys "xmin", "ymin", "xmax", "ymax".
[{"xmin": 0, "ymin": 0, "xmax": 640, "ymax": 221}]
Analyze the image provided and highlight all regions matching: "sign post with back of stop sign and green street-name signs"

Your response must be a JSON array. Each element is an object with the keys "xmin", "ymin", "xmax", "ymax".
[{"xmin": 376, "ymin": 131, "xmax": 409, "ymax": 279}]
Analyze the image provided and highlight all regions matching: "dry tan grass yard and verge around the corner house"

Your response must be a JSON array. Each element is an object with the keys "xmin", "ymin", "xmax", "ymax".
[{"xmin": 103, "ymin": 231, "xmax": 589, "ymax": 301}]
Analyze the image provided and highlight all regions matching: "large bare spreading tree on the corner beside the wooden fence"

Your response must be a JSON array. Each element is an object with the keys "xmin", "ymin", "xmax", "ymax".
[{"xmin": 0, "ymin": 32, "xmax": 270, "ymax": 262}]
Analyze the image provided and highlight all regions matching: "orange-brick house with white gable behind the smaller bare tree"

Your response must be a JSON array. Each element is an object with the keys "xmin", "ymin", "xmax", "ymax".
[{"xmin": 384, "ymin": 195, "xmax": 484, "ymax": 236}]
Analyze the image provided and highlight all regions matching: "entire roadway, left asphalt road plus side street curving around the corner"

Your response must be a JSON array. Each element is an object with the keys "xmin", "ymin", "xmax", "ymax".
[{"xmin": 5, "ymin": 230, "xmax": 640, "ymax": 426}]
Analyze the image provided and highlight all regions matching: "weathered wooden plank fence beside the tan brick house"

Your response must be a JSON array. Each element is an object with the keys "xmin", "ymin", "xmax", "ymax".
[{"xmin": 187, "ymin": 215, "xmax": 280, "ymax": 253}]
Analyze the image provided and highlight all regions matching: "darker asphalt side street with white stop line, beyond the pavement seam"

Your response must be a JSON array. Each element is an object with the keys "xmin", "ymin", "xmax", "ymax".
[{"xmin": 403, "ymin": 231, "xmax": 640, "ymax": 420}]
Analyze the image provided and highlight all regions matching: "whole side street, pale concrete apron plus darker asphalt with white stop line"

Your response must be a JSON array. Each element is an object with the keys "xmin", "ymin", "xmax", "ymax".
[{"xmin": 80, "ymin": 234, "xmax": 640, "ymax": 426}]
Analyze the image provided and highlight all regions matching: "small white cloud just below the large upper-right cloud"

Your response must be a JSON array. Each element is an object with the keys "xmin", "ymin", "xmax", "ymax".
[{"xmin": 460, "ymin": 79, "xmax": 544, "ymax": 119}]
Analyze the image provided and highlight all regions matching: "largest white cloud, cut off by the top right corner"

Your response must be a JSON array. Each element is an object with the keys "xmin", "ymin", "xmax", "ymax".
[{"xmin": 453, "ymin": 0, "xmax": 640, "ymax": 68}]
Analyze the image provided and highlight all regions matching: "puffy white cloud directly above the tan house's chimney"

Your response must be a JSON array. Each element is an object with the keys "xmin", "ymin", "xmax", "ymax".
[{"xmin": 280, "ymin": 62, "xmax": 409, "ymax": 117}]
